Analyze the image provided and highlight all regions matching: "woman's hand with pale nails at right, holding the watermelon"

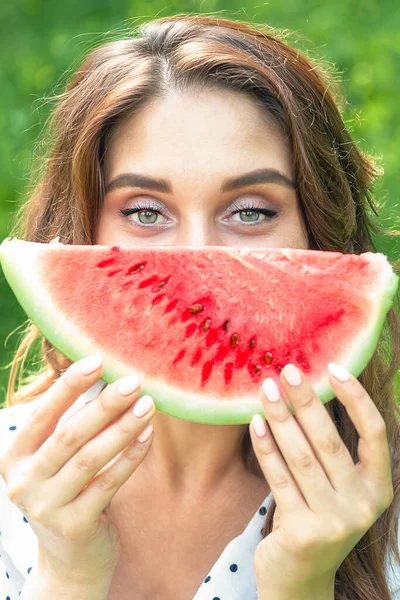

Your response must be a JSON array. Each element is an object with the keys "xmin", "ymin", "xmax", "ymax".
[{"xmin": 250, "ymin": 363, "xmax": 393, "ymax": 598}]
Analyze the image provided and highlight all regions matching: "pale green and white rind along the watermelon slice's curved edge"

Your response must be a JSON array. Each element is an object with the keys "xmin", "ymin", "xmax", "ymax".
[{"xmin": 0, "ymin": 238, "xmax": 399, "ymax": 425}]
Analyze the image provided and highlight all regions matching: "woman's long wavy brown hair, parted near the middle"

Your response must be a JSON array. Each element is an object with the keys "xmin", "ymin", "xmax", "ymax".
[{"xmin": 3, "ymin": 14, "xmax": 400, "ymax": 600}]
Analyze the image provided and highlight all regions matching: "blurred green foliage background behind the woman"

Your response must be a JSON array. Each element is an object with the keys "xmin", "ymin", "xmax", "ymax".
[{"xmin": 0, "ymin": 0, "xmax": 400, "ymax": 406}]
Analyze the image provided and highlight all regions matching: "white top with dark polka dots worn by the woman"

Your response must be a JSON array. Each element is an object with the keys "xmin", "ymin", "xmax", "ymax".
[{"xmin": 0, "ymin": 380, "xmax": 400, "ymax": 600}]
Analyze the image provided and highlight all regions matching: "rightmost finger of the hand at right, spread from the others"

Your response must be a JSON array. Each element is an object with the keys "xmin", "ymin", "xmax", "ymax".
[{"xmin": 328, "ymin": 363, "xmax": 392, "ymax": 494}]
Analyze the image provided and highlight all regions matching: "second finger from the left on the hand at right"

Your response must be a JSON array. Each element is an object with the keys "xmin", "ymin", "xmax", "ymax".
[{"xmin": 260, "ymin": 378, "xmax": 336, "ymax": 513}]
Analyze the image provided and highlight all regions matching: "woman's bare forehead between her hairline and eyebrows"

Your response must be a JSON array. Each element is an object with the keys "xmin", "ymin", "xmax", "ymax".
[{"xmin": 105, "ymin": 90, "xmax": 294, "ymax": 179}]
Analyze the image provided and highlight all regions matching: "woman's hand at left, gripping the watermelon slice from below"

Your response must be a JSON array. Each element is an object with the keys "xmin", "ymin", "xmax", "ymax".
[{"xmin": 0, "ymin": 357, "xmax": 155, "ymax": 584}]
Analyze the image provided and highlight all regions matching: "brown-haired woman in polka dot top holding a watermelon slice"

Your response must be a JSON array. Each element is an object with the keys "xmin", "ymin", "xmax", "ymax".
[{"xmin": 0, "ymin": 15, "xmax": 400, "ymax": 600}]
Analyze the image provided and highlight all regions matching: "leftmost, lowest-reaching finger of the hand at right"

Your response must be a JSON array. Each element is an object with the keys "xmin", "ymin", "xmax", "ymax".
[{"xmin": 250, "ymin": 414, "xmax": 308, "ymax": 514}]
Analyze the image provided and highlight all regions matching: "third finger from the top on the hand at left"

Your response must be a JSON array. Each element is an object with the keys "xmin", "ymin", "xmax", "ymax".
[{"xmin": 46, "ymin": 396, "xmax": 155, "ymax": 506}]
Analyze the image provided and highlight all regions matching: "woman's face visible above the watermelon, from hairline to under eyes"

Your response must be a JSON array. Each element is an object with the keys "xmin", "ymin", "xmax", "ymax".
[{"xmin": 96, "ymin": 91, "xmax": 308, "ymax": 248}]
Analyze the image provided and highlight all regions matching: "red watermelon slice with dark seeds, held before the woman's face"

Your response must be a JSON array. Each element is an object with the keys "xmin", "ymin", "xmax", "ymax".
[{"xmin": 0, "ymin": 239, "xmax": 399, "ymax": 424}]
